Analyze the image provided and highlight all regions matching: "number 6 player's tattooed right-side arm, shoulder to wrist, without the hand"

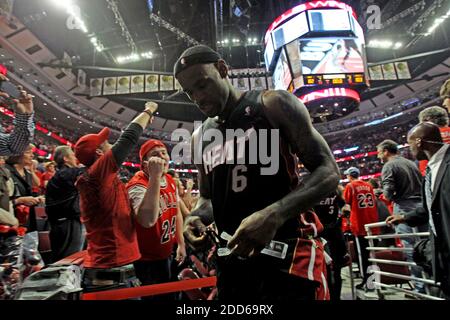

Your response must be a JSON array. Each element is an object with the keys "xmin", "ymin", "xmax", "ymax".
[{"xmin": 263, "ymin": 91, "xmax": 340, "ymax": 223}]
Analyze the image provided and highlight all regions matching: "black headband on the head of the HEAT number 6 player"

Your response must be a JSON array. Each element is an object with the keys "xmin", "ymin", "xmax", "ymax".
[{"xmin": 173, "ymin": 45, "xmax": 222, "ymax": 77}]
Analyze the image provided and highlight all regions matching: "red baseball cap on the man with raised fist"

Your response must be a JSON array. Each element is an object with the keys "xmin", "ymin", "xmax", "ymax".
[{"xmin": 75, "ymin": 128, "xmax": 110, "ymax": 167}]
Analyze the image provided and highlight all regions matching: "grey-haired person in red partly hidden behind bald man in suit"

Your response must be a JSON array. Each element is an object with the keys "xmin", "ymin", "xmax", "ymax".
[{"xmin": 419, "ymin": 106, "xmax": 450, "ymax": 177}]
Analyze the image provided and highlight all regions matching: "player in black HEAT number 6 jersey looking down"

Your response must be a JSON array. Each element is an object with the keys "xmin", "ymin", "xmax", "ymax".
[{"xmin": 174, "ymin": 45, "xmax": 339, "ymax": 300}]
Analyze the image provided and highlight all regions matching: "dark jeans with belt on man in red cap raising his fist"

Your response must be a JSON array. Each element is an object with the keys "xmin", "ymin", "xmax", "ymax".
[{"xmin": 83, "ymin": 264, "xmax": 141, "ymax": 300}]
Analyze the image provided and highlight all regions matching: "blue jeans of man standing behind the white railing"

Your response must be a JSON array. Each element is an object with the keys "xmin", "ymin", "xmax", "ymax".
[{"xmin": 393, "ymin": 200, "xmax": 428, "ymax": 292}]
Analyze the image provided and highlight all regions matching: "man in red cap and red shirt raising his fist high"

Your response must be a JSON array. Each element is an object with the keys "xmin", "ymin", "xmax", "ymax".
[{"xmin": 75, "ymin": 102, "xmax": 158, "ymax": 292}]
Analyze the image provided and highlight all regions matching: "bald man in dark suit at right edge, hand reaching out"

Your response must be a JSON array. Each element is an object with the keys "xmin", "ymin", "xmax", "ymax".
[{"xmin": 386, "ymin": 122, "xmax": 450, "ymax": 300}]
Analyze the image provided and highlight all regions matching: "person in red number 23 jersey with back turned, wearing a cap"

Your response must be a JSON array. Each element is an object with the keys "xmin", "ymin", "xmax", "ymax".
[{"xmin": 344, "ymin": 167, "xmax": 378, "ymax": 289}]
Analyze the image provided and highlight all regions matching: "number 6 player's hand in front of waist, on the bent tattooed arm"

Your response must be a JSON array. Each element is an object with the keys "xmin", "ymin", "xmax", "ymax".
[{"xmin": 228, "ymin": 210, "xmax": 279, "ymax": 258}]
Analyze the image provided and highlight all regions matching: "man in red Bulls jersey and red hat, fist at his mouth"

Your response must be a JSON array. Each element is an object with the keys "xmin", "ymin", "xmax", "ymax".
[{"xmin": 127, "ymin": 140, "xmax": 186, "ymax": 300}]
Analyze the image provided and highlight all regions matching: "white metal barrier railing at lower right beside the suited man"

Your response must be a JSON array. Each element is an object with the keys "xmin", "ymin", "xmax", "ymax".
[{"xmin": 365, "ymin": 222, "xmax": 444, "ymax": 300}]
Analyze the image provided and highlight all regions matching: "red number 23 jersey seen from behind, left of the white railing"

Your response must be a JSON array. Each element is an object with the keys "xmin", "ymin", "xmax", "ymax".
[{"xmin": 344, "ymin": 180, "xmax": 378, "ymax": 236}]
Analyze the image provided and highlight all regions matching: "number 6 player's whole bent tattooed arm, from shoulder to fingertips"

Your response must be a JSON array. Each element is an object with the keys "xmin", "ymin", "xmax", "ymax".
[{"xmin": 228, "ymin": 91, "xmax": 339, "ymax": 257}]
